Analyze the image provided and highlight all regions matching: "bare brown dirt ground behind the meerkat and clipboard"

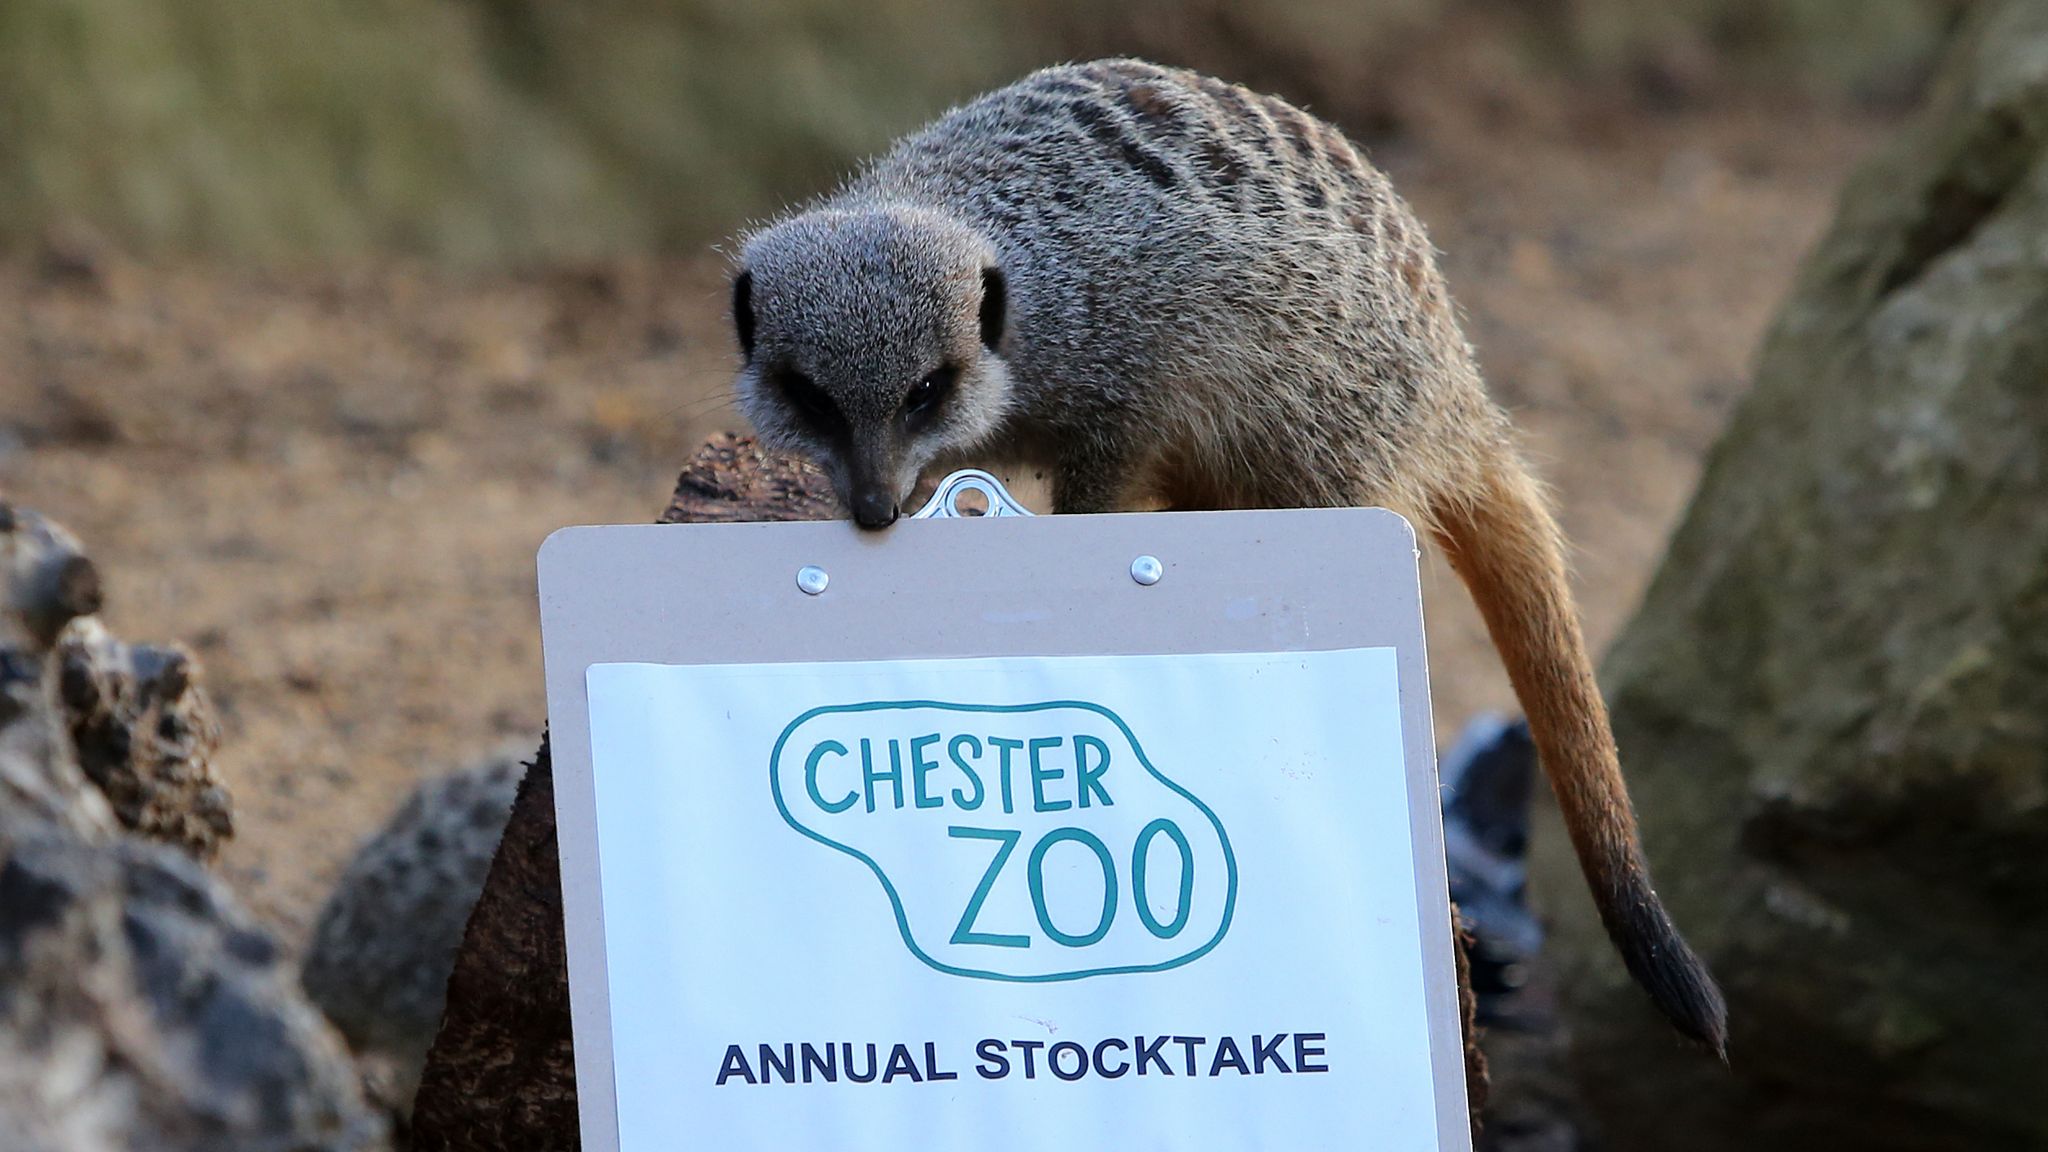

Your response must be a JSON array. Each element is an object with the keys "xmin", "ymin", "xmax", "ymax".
[{"xmin": 0, "ymin": 82, "xmax": 1884, "ymax": 943}]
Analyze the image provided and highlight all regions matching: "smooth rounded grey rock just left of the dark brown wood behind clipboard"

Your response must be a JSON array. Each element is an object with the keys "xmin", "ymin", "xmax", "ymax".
[{"xmin": 299, "ymin": 754, "xmax": 526, "ymax": 1123}]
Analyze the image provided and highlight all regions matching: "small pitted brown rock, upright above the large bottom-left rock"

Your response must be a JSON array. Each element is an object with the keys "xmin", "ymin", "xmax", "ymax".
[{"xmin": 57, "ymin": 617, "xmax": 233, "ymax": 861}]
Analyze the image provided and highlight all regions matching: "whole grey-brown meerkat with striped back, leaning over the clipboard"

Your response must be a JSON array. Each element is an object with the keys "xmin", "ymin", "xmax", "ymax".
[{"xmin": 731, "ymin": 59, "xmax": 1726, "ymax": 1054}]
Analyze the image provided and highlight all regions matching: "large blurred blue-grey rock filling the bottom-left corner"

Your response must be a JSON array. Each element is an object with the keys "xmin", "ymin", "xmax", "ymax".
[{"xmin": 0, "ymin": 818, "xmax": 387, "ymax": 1152}]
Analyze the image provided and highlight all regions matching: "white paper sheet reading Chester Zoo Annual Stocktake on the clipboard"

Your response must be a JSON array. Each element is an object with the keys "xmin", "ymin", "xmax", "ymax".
[{"xmin": 584, "ymin": 648, "xmax": 1462, "ymax": 1152}]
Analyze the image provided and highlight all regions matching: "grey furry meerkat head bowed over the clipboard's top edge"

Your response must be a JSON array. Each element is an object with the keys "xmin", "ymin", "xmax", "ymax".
[{"xmin": 733, "ymin": 205, "xmax": 1010, "ymax": 529}]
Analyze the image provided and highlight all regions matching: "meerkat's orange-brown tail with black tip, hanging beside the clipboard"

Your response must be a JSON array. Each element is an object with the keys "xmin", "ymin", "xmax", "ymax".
[{"xmin": 1430, "ymin": 449, "xmax": 1729, "ymax": 1060}]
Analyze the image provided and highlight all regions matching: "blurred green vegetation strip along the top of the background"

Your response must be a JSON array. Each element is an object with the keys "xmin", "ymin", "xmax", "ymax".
[{"xmin": 0, "ymin": 0, "xmax": 1960, "ymax": 266}]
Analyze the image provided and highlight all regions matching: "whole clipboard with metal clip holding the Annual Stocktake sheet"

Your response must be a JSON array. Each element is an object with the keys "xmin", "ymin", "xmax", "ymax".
[{"xmin": 539, "ymin": 471, "xmax": 1470, "ymax": 1152}]
